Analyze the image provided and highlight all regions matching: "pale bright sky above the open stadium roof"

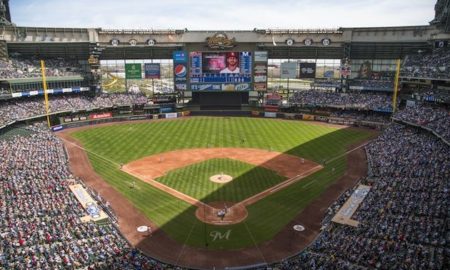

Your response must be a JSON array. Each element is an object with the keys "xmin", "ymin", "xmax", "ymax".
[{"xmin": 9, "ymin": 0, "xmax": 436, "ymax": 30}]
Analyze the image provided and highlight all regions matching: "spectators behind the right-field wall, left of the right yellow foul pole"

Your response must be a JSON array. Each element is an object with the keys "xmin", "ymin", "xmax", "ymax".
[{"xmin": 290, "ymin": 90, "xmax": 392, "ymax": 111}]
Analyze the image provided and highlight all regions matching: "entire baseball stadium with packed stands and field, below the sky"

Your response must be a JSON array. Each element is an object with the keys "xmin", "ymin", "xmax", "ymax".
[{"xmin": 0, "ymin": 0, "xmax": 450, "ymax": 270}]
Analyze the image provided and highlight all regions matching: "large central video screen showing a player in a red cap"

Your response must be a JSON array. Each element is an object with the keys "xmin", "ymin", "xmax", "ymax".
[{"xmin": 189, "ymin": 52, "xmax": 252, "ymax": 91}]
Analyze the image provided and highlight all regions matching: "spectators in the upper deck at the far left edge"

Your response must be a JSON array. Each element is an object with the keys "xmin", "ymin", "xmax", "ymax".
[{"xmin": 0, "ymin": 58, "xmax": 81, "ymax": 80}]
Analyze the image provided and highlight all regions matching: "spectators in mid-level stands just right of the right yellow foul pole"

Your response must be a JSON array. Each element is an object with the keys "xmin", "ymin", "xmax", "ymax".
[{"xmin": 393, "ymin": 104, "xmax": 450, "ymax": 142}]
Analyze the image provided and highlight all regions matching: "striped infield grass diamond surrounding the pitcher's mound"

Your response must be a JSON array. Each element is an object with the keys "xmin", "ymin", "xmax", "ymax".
[{"xmin": 156, "ymin": 158, "xmax": 286, "ymax": 202}]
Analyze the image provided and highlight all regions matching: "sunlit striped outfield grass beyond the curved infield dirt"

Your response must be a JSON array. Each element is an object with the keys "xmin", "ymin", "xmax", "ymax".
[{"xmin": 74, "ymin": 117, "xmax": 342, "ymax": 164}]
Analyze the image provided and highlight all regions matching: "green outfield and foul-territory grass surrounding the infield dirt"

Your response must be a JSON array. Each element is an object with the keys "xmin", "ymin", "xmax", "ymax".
[{"xmin": 73, "ymin": 117, "xmax": 371, "ymax": 249}]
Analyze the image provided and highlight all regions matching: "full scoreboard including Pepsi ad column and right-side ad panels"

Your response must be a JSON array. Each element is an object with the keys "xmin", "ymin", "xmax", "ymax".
[{"xmin": 173, "ymin": 51, "xmax": 267, "ymax": 92}]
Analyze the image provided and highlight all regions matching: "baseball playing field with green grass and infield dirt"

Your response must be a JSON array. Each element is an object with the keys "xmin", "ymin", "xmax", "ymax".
[{"xmin": 62, "ymin": 117, "xmax": 373, "ymax": 262}]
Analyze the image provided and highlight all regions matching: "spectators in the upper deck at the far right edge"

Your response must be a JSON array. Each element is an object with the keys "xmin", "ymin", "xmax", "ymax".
[{"xmin": 400, "ymin": 48, "xmax": 450, "ymax": 79}]
